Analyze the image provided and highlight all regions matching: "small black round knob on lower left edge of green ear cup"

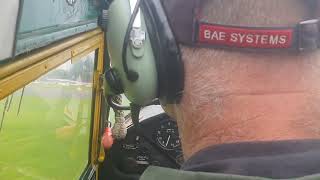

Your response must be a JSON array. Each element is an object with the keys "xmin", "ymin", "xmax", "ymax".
[{"xmin": 104, "ymin": 68, "xmax": 124, "ymax": 94}]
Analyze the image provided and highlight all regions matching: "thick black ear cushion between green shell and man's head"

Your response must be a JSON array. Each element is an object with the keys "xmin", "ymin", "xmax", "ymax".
[{"xmin": 141, "ymin": 0, "xmax": 184, "ymax": 104}]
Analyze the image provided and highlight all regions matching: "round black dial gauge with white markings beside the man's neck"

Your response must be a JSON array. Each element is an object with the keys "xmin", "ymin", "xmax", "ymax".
[{"xmin": 156, "ymin": 121, "xmax": 181, "ymax": 150}]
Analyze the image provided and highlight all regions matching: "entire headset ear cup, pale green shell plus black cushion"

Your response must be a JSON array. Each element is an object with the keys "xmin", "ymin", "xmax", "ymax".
[{"xmin": 105, "ymin": 0, "xmax": 184, "ymax": 106}]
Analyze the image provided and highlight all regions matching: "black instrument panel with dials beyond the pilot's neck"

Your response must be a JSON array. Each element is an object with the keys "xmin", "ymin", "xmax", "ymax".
[{"xmin": 101, "ymin": 114, "xmax": 184, "ymax": 179}]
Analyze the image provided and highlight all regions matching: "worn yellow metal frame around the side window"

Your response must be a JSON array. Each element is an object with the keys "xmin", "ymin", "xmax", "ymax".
[{"xmin": 0, "ymin": 28, "xmax": 105, "ymax": 179}]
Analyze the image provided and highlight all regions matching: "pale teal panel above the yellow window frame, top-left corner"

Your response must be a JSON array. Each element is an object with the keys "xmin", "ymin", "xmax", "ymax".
[{"xmin": 0, "ymin": 0, "xmax": 100, "ymax": 63}]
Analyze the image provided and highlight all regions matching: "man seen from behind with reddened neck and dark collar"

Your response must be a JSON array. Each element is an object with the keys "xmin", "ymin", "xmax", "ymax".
[{"xmin": 141, "ymin": 0, "xmax": 320, "ymax": 180}]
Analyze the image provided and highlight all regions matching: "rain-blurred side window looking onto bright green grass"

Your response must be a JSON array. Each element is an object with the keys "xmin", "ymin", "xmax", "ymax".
[{"xmin": 0, "ymin": 52, "xmax": 95, "ymax": 180}]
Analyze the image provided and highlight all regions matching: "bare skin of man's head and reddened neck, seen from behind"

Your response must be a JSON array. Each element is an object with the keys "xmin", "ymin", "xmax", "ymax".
[{"xmin": 166, "ymin": 0, "xmax": 320, "ymax": 158}]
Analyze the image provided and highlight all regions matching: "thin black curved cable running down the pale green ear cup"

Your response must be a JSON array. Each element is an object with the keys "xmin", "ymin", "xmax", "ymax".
[{"xmin": 122, "ymin": 0, "xmax": 141, "ymax": 82}]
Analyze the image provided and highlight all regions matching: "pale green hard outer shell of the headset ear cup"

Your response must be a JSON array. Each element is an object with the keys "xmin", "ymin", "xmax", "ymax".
[{"xmin": 104, "ymin": 0, "xmax": 158, "ymax": 106}]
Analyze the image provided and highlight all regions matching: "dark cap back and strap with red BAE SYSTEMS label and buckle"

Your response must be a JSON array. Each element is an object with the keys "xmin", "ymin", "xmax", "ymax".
[{"xmin": 162, "ymin": 0, "xmax": 320, "ymax": 51}]
